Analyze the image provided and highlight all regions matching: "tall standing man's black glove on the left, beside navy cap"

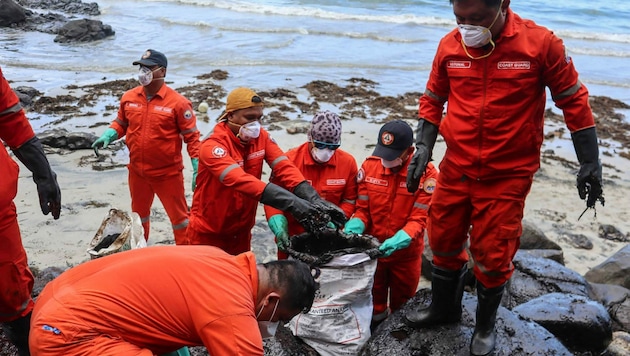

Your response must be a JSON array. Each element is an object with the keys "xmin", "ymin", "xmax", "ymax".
[{"xmin": 407, "ymin": 119, "xmax": 438, "ymax": 193}]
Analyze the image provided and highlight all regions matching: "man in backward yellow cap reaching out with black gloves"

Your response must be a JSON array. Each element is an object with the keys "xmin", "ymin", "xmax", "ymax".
[{"xmin": 188, "ymin": 87, "xmax": 345, "ymax": 255}]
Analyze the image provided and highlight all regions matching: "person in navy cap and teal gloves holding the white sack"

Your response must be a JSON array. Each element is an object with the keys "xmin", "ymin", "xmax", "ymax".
[{"xmin": 344, "ymin": 120, "xmax": 438, "ymax": 329}]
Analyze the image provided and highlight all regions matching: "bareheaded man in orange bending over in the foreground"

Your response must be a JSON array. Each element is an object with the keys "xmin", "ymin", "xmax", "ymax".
[{"xmin": 30, "ymin": 246, "xmax": 318, "ymax": 356}]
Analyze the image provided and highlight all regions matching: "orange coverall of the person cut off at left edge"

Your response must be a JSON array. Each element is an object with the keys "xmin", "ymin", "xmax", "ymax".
[{"xmin": 0, "ymin": 69, "xmax": 35, "ymax": 322}]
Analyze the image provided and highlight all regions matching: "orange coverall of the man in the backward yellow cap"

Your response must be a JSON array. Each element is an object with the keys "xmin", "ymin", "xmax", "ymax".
[{"xmin": 188, "ymin": 122, "xmax": 305, "ymax": 255}]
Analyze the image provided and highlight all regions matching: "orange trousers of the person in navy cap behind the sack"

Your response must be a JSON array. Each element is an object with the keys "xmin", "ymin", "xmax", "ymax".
[{"xmin": 372, "ymin": 253, "xmax": 422, "ymax": 316}]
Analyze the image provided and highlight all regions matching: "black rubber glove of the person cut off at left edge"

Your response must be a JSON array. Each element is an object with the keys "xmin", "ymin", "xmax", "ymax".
[{"xmin": 13, "ymin": 136, "xmax": 61, "ymax": 220}]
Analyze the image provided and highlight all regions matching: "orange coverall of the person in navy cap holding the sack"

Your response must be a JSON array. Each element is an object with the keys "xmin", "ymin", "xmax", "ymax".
[{"xmin": 353, "ymin": 156, "xmax": 438, "ymax": 319}]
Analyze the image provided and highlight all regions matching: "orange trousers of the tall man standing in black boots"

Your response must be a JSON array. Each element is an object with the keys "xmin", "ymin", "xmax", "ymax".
[{"xmin": 429, "ymin": 160, "xmax": 533, "ymax": 288}]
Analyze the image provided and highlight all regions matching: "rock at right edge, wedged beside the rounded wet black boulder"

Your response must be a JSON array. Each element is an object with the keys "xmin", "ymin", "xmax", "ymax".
[{"xmin": 591, "ymin": 283, "xmax": 630, "ymax": 331}]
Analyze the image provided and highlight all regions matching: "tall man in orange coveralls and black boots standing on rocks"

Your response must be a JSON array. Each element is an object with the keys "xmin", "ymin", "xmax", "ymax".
[{"xmin": 407, "ymin": 0, "xmax": 604, "ymax": 355}]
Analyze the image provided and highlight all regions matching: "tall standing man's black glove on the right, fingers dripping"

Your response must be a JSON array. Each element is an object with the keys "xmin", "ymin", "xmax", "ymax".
[{"xmin": 571, "ymin": 127, "xmax": 604, "ymax": 208}]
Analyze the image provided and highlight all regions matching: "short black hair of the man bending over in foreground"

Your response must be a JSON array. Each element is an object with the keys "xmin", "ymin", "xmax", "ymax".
[{"xmin": 263, "ymin": 260, "xmax": 319, "ymax": 313}]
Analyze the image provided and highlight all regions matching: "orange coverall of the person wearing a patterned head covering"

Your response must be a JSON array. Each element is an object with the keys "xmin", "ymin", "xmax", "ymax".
[{"xmin": 265, "ymin": 143, "xmax": 358, "ymax": 259}]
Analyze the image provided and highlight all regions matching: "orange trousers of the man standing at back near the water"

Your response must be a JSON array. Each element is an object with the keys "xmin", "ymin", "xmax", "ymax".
[{"xmin": 129, "ymin": 168, "xmax": 189, "ymax": 245}]
